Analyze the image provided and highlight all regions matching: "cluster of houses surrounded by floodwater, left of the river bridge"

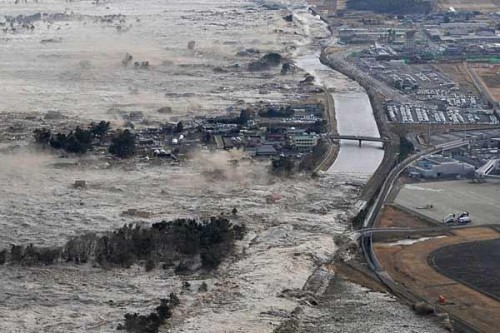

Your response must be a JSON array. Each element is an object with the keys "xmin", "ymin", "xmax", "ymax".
[{"xmin": 133, "ymin": 103, "xmax": 325, "ymax": 159}]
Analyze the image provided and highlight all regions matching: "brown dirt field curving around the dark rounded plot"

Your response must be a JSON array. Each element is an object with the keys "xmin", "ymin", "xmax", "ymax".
[{"xmin": 375, "ymin": 227, "xmax": 500, "ymax": 333}]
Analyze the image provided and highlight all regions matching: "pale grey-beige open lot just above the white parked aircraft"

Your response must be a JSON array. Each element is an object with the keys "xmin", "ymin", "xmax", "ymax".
[{"xmin": 395, "ymin": 180, "xmax": 500, "ymax": 225}]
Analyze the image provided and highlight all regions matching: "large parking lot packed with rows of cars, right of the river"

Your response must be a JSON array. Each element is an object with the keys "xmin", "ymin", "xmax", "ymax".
[{"xmin": 358, "ymin": 58, "xmax": 499, "ymax": 125}]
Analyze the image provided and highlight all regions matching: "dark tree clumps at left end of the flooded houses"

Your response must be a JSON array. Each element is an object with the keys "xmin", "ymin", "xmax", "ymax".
[{"xmin": 33, "ymin": 121, "xmax": 135, "ymax": 158}]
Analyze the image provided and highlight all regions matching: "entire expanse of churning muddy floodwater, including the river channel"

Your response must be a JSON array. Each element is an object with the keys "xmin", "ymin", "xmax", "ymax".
[{"xmin": 0, "ymin": 0, "xmax": 441, "ymax": 333}]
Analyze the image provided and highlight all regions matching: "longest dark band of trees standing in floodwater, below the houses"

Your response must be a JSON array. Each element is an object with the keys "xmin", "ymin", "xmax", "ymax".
[{"xmin": 0, "ymin": 217, "xmax": 246, "ymax": 270}]
